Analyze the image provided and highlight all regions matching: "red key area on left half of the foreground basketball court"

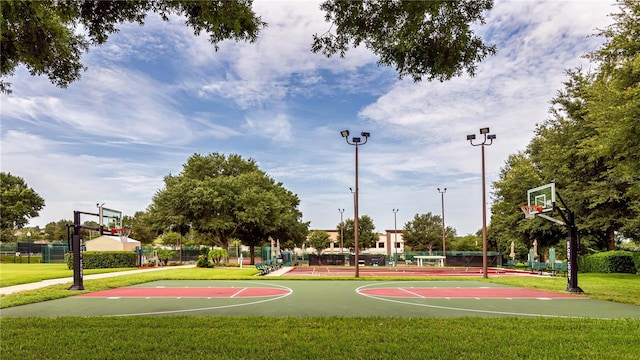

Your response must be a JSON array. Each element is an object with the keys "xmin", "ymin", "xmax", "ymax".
[{"xmin": 77, "ymin": 287, "xmax": 291, "ymax": 299}]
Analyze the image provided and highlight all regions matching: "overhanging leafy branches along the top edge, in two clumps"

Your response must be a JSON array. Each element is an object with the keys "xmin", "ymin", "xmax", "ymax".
[{"xmin": 0, "ymin": 0, "xmax": 495, "ymax": 93}]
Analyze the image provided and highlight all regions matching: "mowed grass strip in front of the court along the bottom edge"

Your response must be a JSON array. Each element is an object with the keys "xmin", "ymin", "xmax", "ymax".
[{"xmin": 2, "ymin": 316, "xmax": 640, "ymax": 360}]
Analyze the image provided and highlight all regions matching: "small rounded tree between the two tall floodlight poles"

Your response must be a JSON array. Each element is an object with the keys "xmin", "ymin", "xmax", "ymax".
[{"xmin": 402, "ymin": 212, "xmax": 456, "ymax": 252}]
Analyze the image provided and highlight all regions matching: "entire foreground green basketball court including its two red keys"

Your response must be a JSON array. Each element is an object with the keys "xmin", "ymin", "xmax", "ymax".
[{"xmin": 1, "ymin": 280, "xmax": 640, "ymax": 319}]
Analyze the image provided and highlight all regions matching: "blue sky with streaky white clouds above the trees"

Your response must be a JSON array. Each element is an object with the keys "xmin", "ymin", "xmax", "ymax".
[{"xmin": 0, "ymin": 0, "xmax": 617, "ymax": 235}]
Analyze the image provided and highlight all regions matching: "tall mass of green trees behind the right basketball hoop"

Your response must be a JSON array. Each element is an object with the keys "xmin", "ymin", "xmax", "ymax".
[{"xmin": 491, "ymin": 0, "xmax": 640, "ymax": 250}]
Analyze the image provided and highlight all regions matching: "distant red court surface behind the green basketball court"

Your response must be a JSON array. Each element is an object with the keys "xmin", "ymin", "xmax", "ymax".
[{"xmin": 282, "ymin": 266, "xmax": 533, "ymax": 277}]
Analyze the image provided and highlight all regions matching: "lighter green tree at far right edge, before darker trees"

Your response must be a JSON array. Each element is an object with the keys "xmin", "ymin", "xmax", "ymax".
[{"xmin": 579, "ymin": 0, "xmax": 640, "ymax": 242}]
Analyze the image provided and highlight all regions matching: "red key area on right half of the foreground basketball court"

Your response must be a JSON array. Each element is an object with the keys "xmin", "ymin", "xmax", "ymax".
[{"xmin": 359, "ymin": 287, "xmax": 580, "ymax": 299}]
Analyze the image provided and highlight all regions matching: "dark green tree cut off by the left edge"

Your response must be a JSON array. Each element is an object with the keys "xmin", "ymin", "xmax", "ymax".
[{"xmin": 0, "ymin": 172, "xmax": 44, "ymax": 240}]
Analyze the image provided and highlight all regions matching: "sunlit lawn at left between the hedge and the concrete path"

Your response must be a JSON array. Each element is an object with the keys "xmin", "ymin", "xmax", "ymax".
[{"xmin": 0, "ymin": 263, "xmax": 136, "ymax": 287}]
